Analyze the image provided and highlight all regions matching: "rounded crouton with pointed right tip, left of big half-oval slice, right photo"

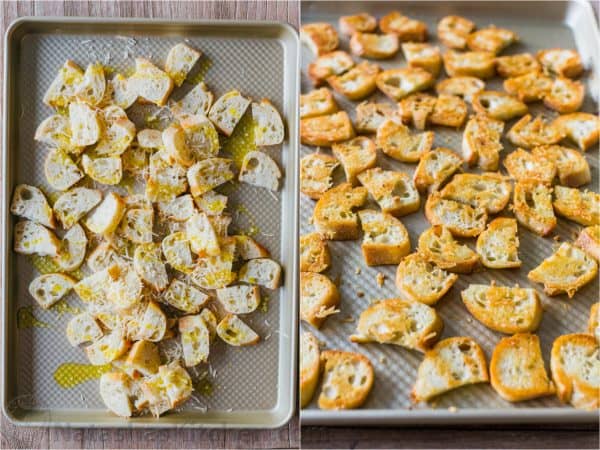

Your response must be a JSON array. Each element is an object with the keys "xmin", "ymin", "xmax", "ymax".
[{"xmin": 396, "ymin": 253, "xmax": 458, "ymax": 305}]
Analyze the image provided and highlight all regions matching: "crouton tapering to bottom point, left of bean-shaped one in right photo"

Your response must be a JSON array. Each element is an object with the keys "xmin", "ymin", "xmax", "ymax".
[{"xmin": 331, "ymin": 136, "xmax": 377, "ymax": 185}]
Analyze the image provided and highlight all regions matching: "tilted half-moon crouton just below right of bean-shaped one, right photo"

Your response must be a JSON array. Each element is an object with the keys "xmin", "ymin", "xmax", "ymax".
[{"xmin": 413, "ymin": 147, "xmax": 463, "ymax": 192}]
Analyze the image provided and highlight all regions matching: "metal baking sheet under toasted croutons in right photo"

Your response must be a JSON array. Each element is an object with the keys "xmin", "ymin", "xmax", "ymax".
[{"xmin": 300, "ymin": 1, "xmax": 600, "ymax": 425}]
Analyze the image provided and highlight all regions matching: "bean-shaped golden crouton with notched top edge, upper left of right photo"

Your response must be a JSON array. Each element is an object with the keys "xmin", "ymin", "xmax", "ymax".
[{"xmin": 375, "ymin": 119, "xmax": 433, "ymax": 163}]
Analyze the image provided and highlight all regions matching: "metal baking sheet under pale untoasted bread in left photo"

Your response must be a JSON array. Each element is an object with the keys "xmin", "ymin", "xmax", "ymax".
[{"xmin": 2, "ymin": 18, "xmax": 299, "ymax": 428}]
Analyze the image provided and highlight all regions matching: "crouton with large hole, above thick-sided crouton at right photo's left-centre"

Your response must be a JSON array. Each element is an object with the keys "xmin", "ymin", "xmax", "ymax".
[{"xmin": 358, "ymin": 167, "xmax": 421, "ymax": 216}]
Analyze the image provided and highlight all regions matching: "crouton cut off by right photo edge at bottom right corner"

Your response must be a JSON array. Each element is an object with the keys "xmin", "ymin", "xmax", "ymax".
[{"xmin": 550, "ymin": 334, "xmax": 600, "ymax": 410}]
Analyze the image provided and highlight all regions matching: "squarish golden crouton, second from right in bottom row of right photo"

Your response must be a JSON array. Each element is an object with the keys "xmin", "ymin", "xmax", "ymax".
[{"xmin": 490, "ymin": 334, "xmax": 556, "ymax": 402}]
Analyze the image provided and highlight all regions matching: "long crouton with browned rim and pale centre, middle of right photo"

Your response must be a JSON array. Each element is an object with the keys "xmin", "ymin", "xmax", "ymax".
[{"xmin": 425, "ymin": 192, "xmax": 488, "ymax": 237}]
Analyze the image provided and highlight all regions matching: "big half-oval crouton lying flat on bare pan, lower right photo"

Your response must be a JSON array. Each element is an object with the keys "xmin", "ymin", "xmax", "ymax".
[{"xmin": 460, "ymin": 284, "xmax": 543, "ymax": 334}]
